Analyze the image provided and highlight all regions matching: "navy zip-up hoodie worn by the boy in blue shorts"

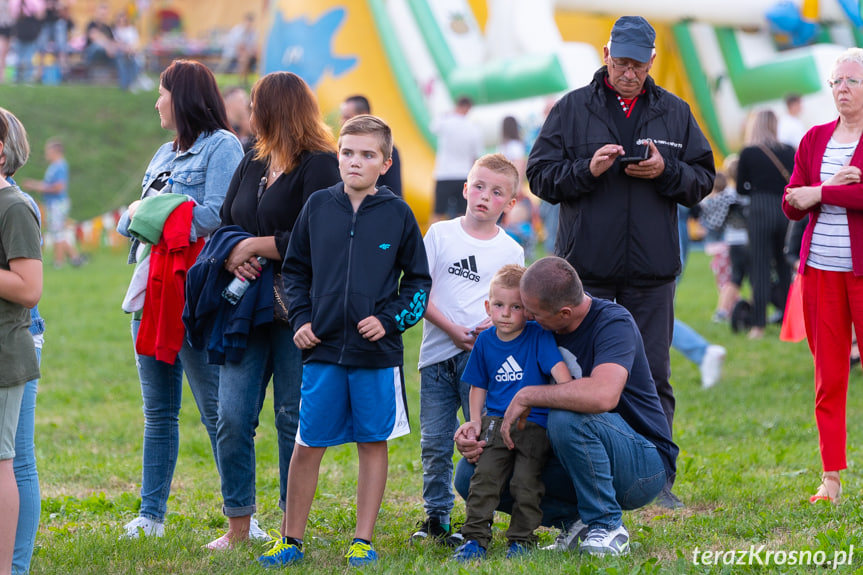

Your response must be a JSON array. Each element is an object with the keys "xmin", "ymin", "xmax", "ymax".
[{"xmin": 282, "ymin": 182, "xmax": 431, "ymax": 368}]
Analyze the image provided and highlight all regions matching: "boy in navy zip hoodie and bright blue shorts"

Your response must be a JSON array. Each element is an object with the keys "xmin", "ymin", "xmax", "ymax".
[{"xmin": 258, "ymin": 115, "xmax": 431, "ymax": 567}]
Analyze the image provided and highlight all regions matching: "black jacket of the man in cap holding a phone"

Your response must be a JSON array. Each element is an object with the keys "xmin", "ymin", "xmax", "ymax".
[{"xmin": 527, "ymin": 67, "xmax": 716, "ymax": 286}]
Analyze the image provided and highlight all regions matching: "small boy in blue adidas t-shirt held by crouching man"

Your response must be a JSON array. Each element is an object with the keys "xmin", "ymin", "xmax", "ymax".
[{"xmin": 453, "ymin": 264, "xmax": 572, "ymax": 562}]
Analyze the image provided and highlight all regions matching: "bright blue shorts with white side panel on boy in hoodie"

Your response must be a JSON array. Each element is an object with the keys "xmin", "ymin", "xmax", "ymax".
[{"xmin": 297, "ymin": 362, "xmax": 411, "ymax": 447}]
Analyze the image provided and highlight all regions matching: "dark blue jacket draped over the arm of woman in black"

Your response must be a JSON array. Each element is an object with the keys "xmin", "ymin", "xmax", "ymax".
[{"xmin": 183, "ymin": 226, "xmax": 273, "ymax": 365}]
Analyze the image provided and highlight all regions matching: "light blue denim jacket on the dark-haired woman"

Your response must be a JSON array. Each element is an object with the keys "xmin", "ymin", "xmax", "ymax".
[{"xmin": 117, "ymin": 130, "xmax": 243, "ymax": 239}]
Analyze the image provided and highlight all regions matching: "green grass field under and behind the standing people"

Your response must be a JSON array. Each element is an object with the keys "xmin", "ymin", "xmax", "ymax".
[{"xmin": 6, "ymin": 86, "xmax": 863, "ymax": 575}]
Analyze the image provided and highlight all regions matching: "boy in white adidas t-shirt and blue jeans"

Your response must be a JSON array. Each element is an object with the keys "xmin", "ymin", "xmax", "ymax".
[{"xmin": 411, "ymin": 154, "xmax": 524, "ymax": 547}]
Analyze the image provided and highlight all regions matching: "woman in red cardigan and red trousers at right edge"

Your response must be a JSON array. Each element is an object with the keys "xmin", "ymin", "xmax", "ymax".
[{"xmin": 782, "ymin": 48, "xmax": 863, "ymax": 503}]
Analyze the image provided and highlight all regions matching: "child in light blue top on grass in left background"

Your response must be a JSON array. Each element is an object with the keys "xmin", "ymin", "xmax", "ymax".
[{"xmin": 24, "ymin": 139, "xmax": 86, "ymax": 269}]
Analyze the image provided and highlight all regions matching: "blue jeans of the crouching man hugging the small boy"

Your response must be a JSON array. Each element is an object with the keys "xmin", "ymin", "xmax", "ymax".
[{"xmin": 455, "ymin": 409, "xmax": 665, "ymax": 529}]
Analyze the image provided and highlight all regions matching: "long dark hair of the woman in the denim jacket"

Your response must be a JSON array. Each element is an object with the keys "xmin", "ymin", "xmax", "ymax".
[{"xmin": 159, "ymin": 60, "xmax": 232, "ymax": 150}]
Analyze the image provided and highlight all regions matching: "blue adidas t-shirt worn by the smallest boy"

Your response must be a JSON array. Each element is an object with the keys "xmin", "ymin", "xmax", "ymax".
[{"xmin": 462, "ymin": 321, "xmax": 563, "ymax": 427}]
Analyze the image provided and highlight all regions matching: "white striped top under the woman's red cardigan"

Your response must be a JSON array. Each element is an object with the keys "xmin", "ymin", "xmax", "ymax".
[{"xmin": 806, "ymin": 138, "xmax": 857, "ymax": 272}]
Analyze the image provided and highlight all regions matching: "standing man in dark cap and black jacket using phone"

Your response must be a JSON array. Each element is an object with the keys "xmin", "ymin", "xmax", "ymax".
[{"xmin": 527, "ymin": 12, "xmax": 715, "ymax": 540}]
